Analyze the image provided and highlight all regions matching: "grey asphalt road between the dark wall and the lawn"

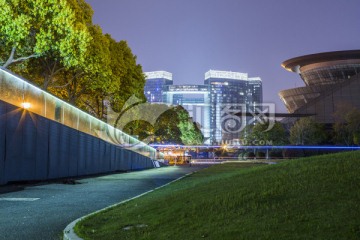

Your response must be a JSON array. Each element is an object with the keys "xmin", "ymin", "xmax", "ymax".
[{"xmin": 0, "ymin": 165, "xmax": 205, "ymax": 240}]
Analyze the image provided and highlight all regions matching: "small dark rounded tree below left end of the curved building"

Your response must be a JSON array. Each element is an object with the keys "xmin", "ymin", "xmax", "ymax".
[{"xmin": 290, "ymin": 117, "xmax": 327, "ymax": 145}]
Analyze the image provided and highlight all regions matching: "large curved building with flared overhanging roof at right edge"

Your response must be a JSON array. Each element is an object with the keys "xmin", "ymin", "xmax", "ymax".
[{"xmin": 279, "ymin": 50, "xmax": 360, "ymax": 123}]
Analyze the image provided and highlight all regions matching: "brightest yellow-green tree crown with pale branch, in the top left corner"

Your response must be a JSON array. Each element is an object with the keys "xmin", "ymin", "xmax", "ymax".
[{"xmin": 0, "ymin": 0, "xmax": 92, "ymax": 71}]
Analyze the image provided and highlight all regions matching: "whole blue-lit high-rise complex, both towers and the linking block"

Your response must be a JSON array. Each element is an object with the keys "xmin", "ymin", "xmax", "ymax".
[{"xmin": 145, "ymin": 70, "xmax": 262, "ymax": 144}]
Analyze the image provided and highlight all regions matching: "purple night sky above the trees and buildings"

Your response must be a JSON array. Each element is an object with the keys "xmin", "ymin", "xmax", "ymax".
[{"xmin": 86, "ymin": 0, "xmax": 360, "ymax": 112}]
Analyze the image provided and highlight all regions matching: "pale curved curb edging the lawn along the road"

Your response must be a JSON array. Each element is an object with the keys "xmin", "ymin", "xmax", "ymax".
[{"xmin": 63, "ymin": 171, "xmax": 197, "ymax": 240}]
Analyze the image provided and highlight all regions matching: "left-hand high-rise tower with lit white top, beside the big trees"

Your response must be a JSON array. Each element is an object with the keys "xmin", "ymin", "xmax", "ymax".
[{"xmin": 144, "ymin": 71, "xmax": 173, "ymax": 103}]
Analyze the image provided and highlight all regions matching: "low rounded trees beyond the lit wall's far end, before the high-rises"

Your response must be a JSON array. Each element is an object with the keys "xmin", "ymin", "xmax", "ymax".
[{"xmin": 113, "ymin": 103, "xmax": 203, "ymax": 145}]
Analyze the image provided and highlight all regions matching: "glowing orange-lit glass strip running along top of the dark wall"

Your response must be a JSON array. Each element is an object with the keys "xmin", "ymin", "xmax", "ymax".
[{"xmin": 0, "ymin": 69, "xmax": 156, "ymax": 158}]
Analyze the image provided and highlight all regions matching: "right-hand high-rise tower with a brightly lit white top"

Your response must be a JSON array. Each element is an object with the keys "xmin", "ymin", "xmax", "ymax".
[{"xmin": 205, "ymin": 70, "xmax": 262, "ymax": 144}]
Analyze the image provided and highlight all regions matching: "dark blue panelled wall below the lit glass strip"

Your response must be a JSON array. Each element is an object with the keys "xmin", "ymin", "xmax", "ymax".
[{"xmin": 0, "ymin": 101, "xmax": 154, "ymax": 184}]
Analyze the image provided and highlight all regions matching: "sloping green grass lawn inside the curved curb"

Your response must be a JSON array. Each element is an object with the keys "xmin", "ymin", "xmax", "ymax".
[{"xmin": 75, "ymin": 152, "xmax": 360, "ymax": 240}]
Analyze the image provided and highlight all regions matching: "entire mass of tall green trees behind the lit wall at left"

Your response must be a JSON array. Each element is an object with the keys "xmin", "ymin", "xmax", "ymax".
[{"xmin": 0, "ymin": 0, "xmax": 145, "ymax": 124}]
